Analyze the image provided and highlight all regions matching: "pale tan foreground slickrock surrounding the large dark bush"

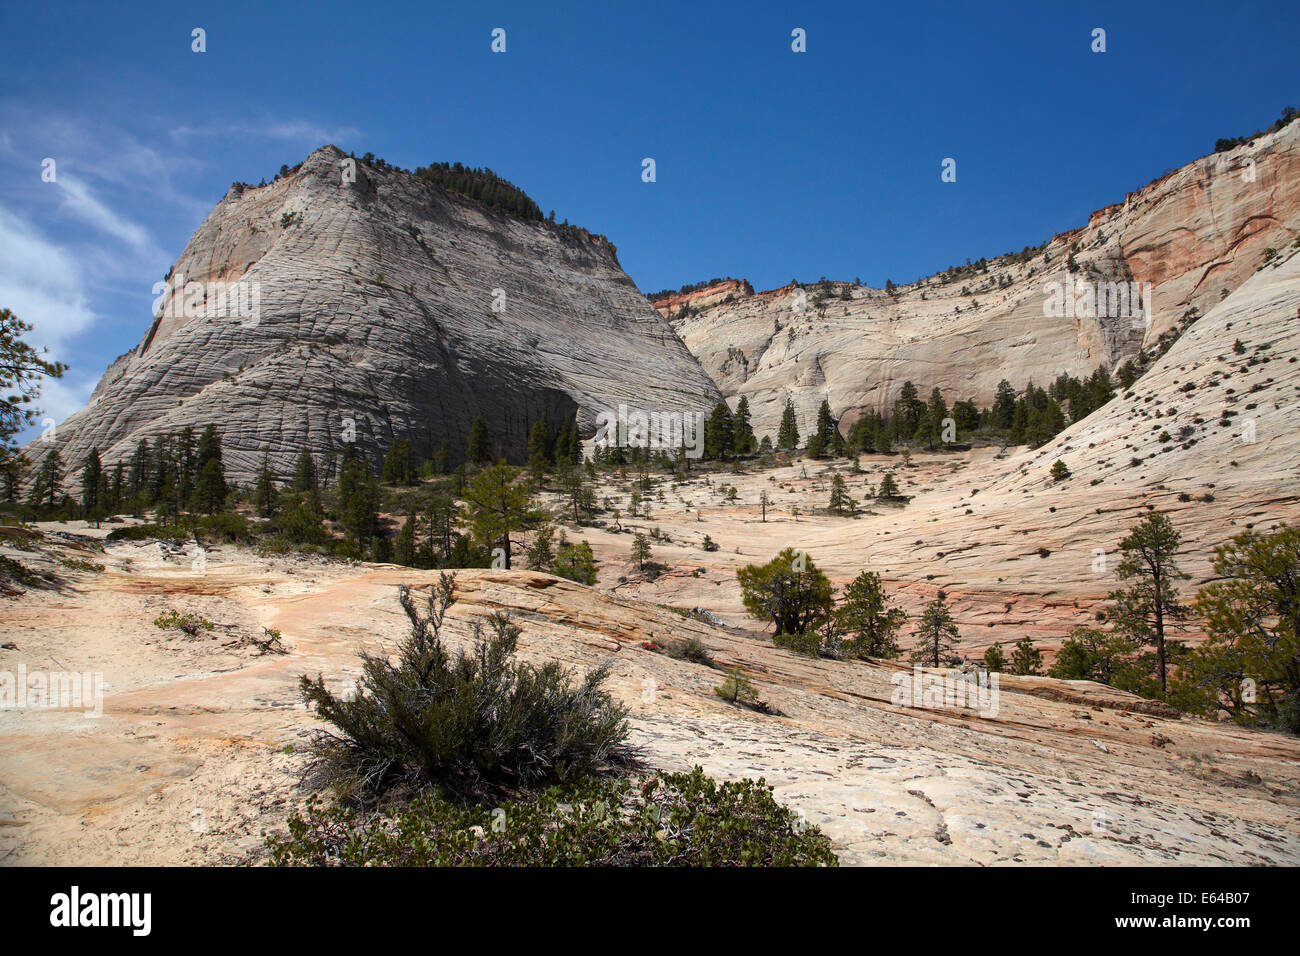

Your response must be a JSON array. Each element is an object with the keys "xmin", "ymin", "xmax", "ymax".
[{"xmin": 0, "ymin": 544, "xmax": 1300, "ymax": 865}]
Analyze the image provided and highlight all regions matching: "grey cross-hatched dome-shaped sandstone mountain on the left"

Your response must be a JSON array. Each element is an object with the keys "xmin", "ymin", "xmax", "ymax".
[{"xmin": 29, "ymin": 147, "xmax": 720, "ymax": 481}]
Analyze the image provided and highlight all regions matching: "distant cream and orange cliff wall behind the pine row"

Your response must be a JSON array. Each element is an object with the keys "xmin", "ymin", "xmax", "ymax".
[{"xmin": 655, "ymin": 124, "xmax": 1300, "ymax": 438}]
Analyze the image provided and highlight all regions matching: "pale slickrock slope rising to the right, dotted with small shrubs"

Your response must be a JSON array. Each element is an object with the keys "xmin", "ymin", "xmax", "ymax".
[{"xmin": 556, "ymin": 240, "xmax": 1300, "ymax": 657}]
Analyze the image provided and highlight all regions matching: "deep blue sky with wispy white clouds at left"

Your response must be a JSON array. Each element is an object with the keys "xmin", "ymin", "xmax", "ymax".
[{"xmin": 0, "ymin": 0, "xmax": 1300, "ymax": 419}]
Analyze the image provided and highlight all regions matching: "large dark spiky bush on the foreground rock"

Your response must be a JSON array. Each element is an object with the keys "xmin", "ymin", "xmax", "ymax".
[{"xmin": 302, "ymin": 574, "xmax": 634, "ymax": 804}]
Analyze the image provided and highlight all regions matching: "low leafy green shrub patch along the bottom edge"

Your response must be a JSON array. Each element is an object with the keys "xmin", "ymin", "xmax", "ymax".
[{"xmin": 268, "ymin": 766, "xmax": 837, "ymax": 866}]
